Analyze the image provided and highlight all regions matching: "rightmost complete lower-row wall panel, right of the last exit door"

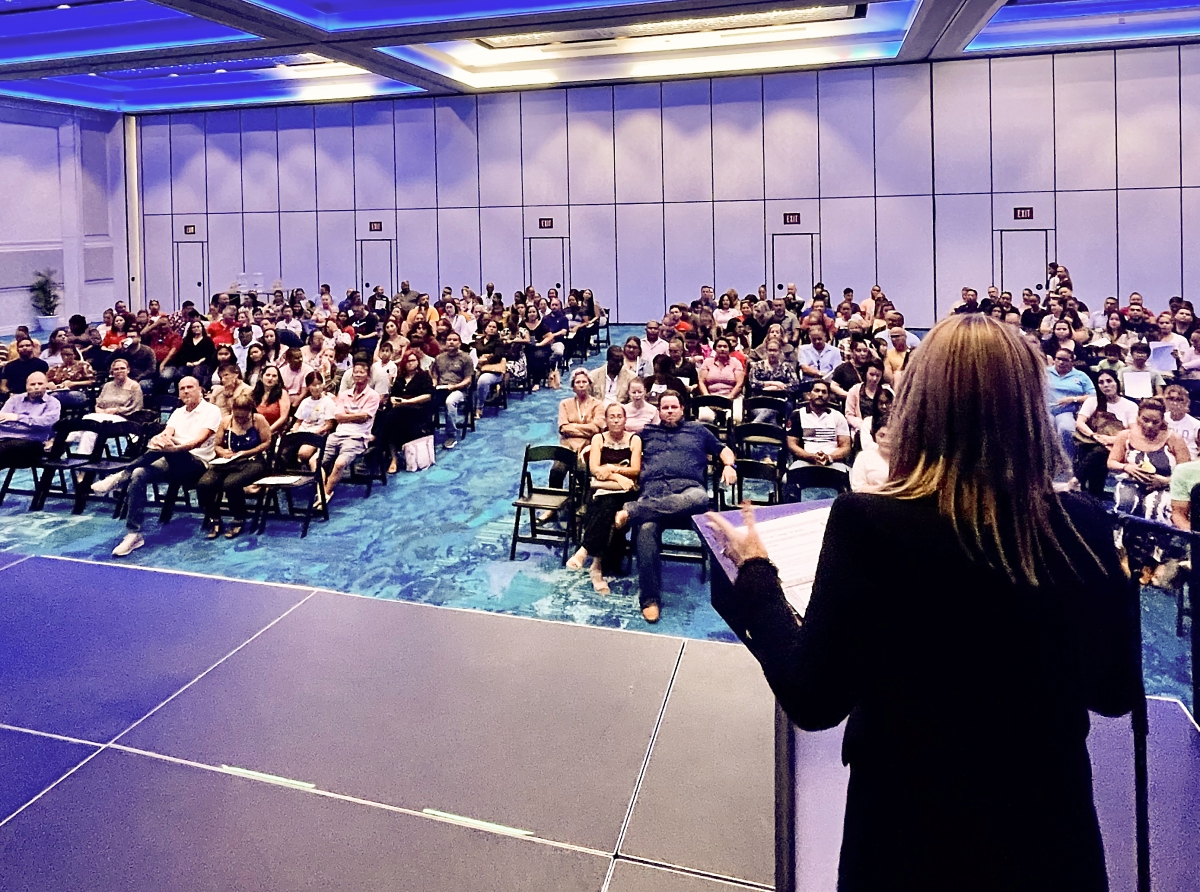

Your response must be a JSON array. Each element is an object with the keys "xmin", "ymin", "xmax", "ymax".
[{"xmin": 1113, "ymin": 186, "xmax": 1183, "ymax": 301}]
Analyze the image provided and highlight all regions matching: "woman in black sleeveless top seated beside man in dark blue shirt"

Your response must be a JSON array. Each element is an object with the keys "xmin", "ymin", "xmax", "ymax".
[{"xmin": 566, "ymin": 403, "xmax": 649, "ymax": 594}]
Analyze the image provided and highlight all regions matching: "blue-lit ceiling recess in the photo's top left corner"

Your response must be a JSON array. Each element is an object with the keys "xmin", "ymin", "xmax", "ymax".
[{"xmin": 0, "ymin": 0, "xmax": 260, "ymax": 64}]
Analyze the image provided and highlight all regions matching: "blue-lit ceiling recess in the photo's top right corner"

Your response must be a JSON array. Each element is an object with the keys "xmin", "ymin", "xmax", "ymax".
[{"xmin": 966, "ymin": 0, "xmax": 1200, "ymax": 53}]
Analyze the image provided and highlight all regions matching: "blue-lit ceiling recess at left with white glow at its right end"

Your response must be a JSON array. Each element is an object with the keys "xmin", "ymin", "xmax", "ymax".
[{"xmin": 0, "ymin": 55, "xmax": 421, "ymax": 112}]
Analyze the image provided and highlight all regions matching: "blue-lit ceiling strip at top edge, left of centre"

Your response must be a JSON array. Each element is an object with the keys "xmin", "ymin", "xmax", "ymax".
[{"xmin": 235, "ymin": 0, "xmax": 676, "ymax": 31}]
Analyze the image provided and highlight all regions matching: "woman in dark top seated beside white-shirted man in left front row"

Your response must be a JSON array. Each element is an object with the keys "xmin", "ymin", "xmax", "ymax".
[{"xmin": 196, "ymin": 393, "xmax": 271, "ymax": 539}]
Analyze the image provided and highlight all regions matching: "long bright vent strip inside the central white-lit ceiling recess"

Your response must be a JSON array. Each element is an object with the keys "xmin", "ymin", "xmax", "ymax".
[{"xmin": 478, "ymin": 4, "xmax": 866, "ymax": 49}]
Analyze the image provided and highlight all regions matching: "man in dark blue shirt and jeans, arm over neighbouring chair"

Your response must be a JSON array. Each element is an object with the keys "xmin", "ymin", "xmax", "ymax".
[{"xmin": 614, "ymin": 390, "xmax": 738, "ymax": 623}]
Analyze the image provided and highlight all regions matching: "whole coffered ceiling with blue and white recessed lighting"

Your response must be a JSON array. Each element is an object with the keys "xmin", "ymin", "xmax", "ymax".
[{"xmin": 0, "ymin": 0, "xmax": 1200, "ymax": 112}]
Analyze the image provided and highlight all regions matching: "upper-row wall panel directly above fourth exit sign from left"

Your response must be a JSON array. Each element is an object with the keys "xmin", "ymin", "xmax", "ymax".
[{"xmin": 762, "ymin": 71, "xmax": 821, "ymax": 198}]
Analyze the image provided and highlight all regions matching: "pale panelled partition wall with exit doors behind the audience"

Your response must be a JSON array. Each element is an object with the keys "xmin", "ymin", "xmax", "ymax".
[{"xmin": 139, "ymin": 46, "xmax": 1200, "ymax": 327}]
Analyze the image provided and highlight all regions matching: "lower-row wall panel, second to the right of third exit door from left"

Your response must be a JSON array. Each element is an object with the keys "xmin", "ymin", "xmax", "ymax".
[{"xmin": 619, "ymin": 204, "xmax": 666, "ymax": 323}]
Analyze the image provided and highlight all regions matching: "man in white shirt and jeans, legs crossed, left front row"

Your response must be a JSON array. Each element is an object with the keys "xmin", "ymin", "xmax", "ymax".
[{"xmin": 91, "ymin": 376, "xmax": 221, "ymax": 557}]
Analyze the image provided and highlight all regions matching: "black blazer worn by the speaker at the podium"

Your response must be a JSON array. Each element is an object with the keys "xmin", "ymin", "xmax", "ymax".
[{"xmin": 714, "ymin": 493, "xmax": 1142, "ymax": 892}]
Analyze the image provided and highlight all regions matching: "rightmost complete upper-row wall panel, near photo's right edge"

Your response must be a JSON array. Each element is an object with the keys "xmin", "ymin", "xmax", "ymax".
[{"xmin": 1116, "ymin": 47, "xmax": 1180, "ymax": 189}]
